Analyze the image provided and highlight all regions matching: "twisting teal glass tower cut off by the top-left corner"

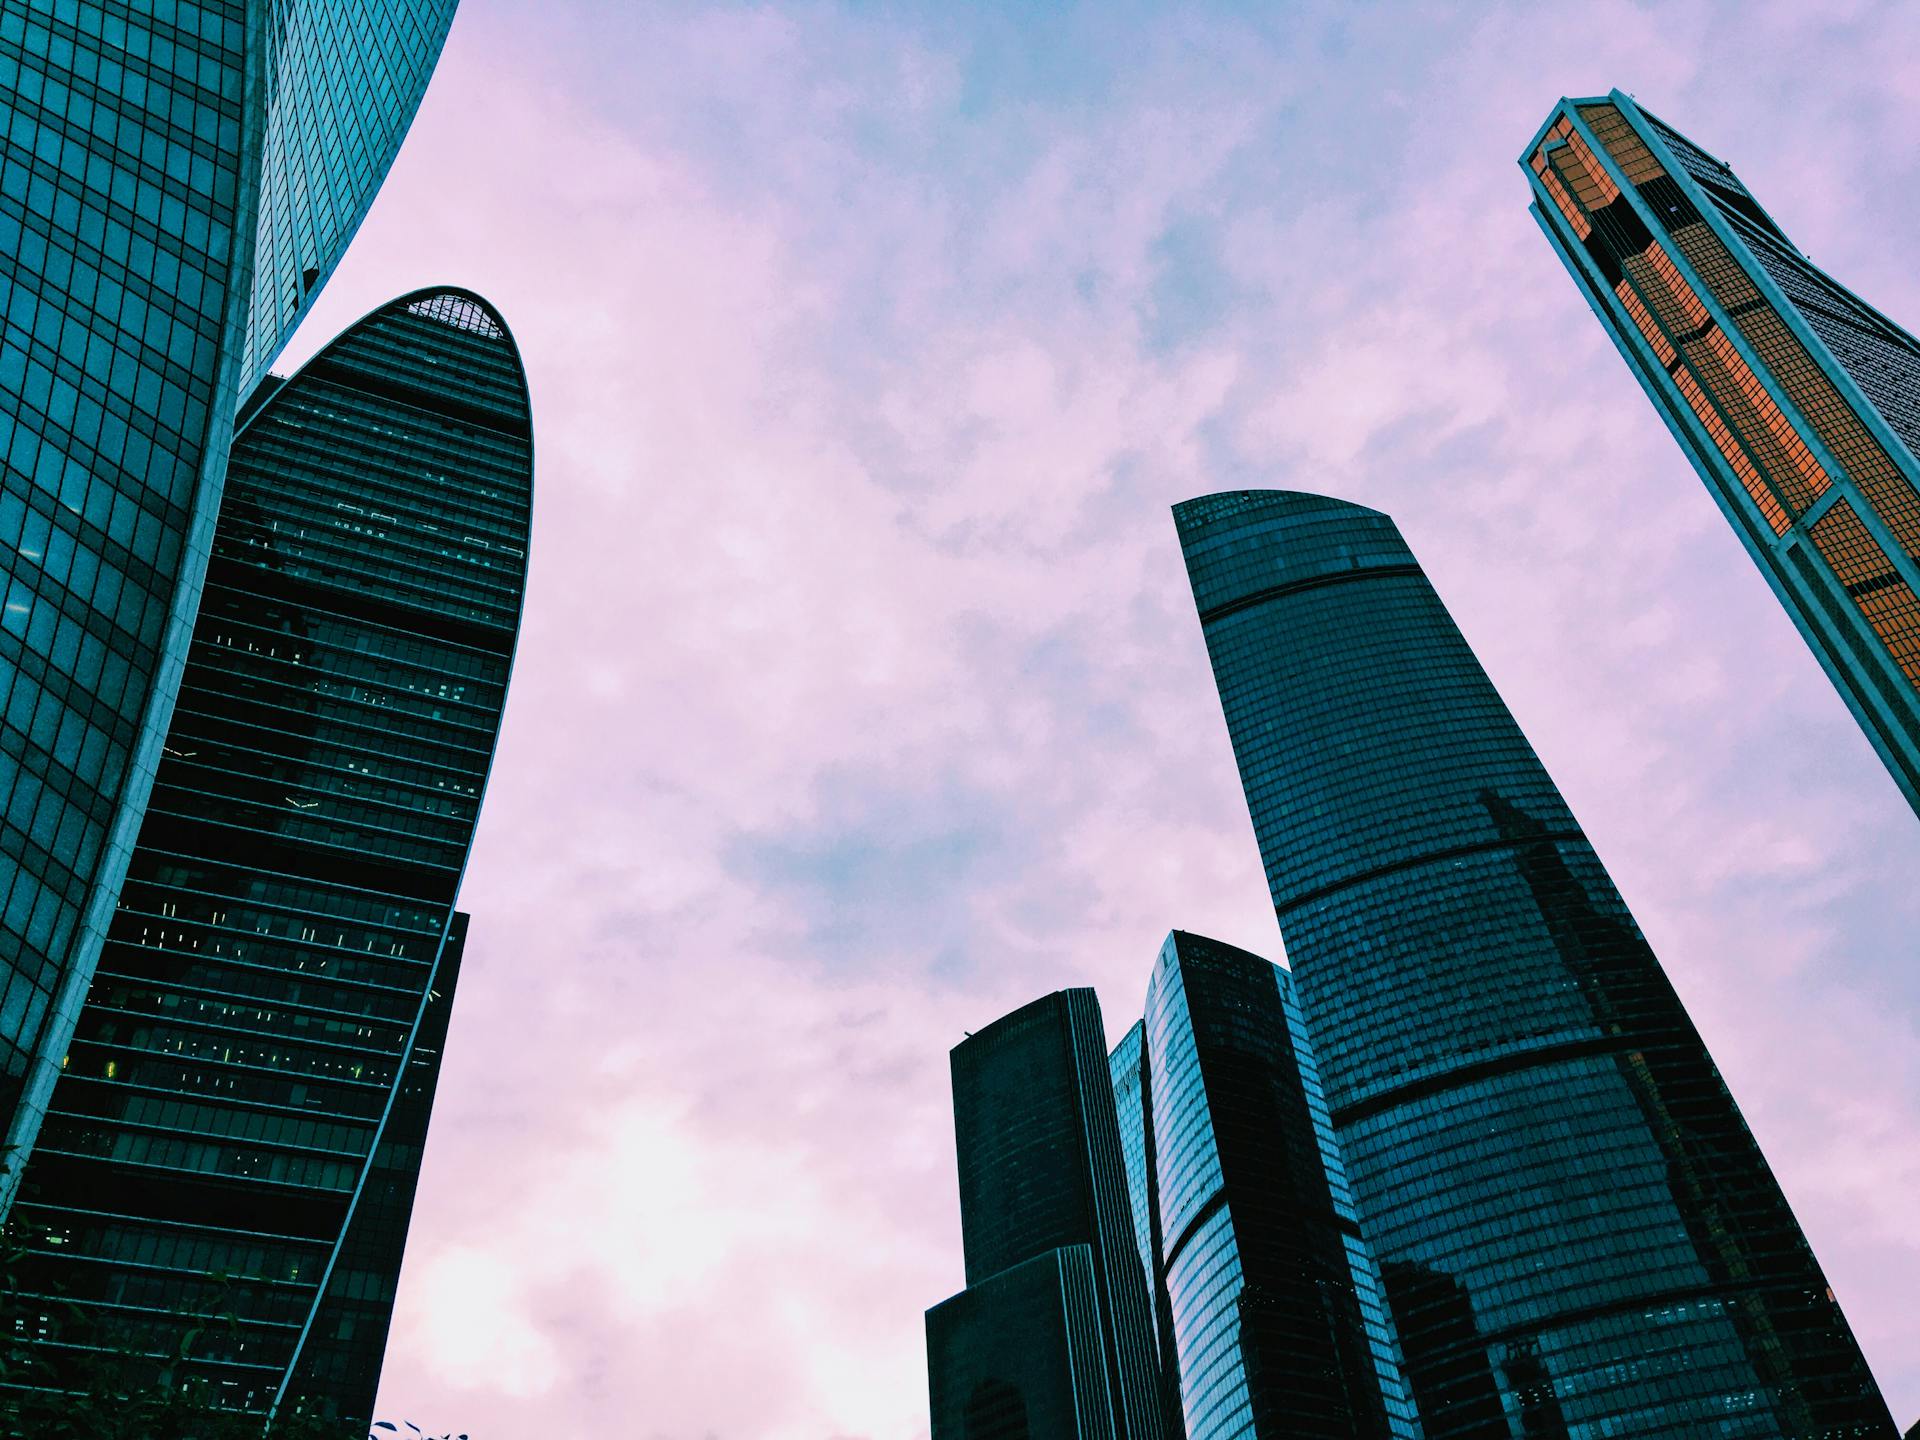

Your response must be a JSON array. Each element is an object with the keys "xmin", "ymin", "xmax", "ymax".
[{"xmin": 0, "ymin": 0, "xmax": 453, "ymax": 1213}]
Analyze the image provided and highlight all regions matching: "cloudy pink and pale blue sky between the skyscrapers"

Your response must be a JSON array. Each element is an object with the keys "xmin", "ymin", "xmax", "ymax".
[{"xmin": 278, "ymin": 0, "xmax": 1920, "ymax": 1440}]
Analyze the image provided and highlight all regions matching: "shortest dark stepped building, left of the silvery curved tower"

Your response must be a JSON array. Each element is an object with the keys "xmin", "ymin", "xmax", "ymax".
[{"xmin": 927, "ymin": 991, "xmax": 1165, "ymax": 1440}]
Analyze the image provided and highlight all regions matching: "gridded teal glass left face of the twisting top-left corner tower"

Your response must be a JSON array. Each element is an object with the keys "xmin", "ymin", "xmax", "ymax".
[{"xmin": 0, "ymin": 0, "xmax": 248, "ymax": 1182}]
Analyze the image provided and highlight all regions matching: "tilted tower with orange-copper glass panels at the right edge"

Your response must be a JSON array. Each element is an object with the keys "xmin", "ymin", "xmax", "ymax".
[{"xmin": 1521, "ymin": 90, "xmax": 1920, "ymax": 810}]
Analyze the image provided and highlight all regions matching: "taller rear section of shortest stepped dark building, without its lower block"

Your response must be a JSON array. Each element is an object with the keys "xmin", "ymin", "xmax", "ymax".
[{"xmin": 929, "ymin": 991, "xmax": 1165, "ymax": 1440}]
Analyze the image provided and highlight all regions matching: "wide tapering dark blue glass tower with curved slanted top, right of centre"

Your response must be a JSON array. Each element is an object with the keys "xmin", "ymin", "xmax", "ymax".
[{"xmin": 1175, "ymin": 492, "xmax": 1893, "ymax": 1440}]
